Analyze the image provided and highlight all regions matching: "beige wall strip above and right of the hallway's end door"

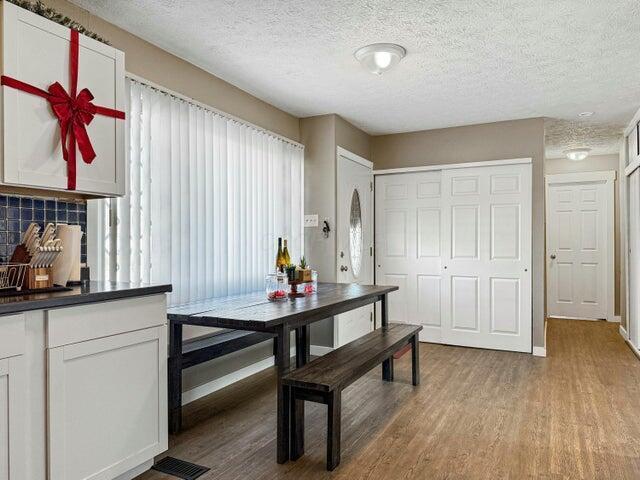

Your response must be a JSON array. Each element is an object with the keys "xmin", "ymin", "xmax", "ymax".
[{"xmin": 545, "ymin": 153, "xmax": 624, "ymax": 323}]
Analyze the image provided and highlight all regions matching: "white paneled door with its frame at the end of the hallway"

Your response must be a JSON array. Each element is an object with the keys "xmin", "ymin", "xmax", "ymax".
[{"xmin": 547, "ymin": 172, "xmax": 614, "ymax": 320}]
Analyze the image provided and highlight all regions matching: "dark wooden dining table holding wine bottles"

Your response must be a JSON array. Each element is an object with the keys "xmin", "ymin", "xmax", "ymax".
[{"xmin": 167, "ymin": 283, "xmax": 398, "ymax": 463}]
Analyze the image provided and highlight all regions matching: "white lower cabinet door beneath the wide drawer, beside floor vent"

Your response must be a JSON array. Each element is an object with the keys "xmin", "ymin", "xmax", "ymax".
[{"xmin": 48, "ymin": 327, "xmax": 167, "ymax": 480}]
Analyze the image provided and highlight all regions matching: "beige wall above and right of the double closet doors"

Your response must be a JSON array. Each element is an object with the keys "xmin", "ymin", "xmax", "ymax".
[{"xmin": 371, "ymin": 118, "xmax": 545, "ymax": 347}]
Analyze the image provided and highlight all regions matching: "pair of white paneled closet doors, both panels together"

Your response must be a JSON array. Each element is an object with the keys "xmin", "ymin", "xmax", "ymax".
[{"xmin": 375, "ymin": 163, "xmax": 531, "ymax": 352}]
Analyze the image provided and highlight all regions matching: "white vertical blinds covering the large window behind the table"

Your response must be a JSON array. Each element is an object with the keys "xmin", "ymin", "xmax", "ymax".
[{"xmin": 101, "ymin": 80, "xmax": 304, "ymax": 305}]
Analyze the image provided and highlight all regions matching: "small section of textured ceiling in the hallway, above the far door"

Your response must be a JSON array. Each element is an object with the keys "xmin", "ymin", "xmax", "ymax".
[{"xmin": 544, "ymin": 118, "xmax": 625, "ymax": 158}]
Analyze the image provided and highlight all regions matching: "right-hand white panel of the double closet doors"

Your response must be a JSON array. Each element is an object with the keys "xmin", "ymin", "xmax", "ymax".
[{"xmin": 442, "ymin": 164, "xmax": 531, "ymax": 352}]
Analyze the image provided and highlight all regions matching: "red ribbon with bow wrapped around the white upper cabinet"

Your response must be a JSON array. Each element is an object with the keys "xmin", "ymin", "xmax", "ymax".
[{"xmin": 0, "ymin": 30, "xmax": 125, "ymax": 190}]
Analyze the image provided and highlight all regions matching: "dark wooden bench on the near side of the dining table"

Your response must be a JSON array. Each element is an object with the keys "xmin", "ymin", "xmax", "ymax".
[{"xmin": 282, "ymin": 323, "xmax": 422, "ymax": 470}]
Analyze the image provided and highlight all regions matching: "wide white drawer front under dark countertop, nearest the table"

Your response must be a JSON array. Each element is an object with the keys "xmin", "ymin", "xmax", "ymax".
[{"xmin": 47, "ymin": 294, "xmax": 167, "ymax": 348}]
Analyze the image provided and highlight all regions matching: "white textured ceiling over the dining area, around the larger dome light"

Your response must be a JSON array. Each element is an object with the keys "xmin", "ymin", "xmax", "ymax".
[{"xmin": 72, "ymin": 0, "xmax": 640, "ymax": 139}]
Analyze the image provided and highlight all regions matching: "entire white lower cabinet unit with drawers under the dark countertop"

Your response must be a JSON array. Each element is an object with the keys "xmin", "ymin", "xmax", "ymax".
[{"xmin": 0, "ymin": 294, "xmax": 168, "ymax": 480}]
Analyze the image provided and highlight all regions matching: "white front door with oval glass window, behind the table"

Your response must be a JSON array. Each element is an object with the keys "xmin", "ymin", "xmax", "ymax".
[{"xmin": 334, "ymin": 151, "xmax": 373, "ymax": 346}]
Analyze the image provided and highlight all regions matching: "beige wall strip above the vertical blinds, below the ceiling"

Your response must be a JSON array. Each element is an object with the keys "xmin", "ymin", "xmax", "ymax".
[{"xmin": 44, "ymin": 0, "xmax": 300, "ymax": 141}]
